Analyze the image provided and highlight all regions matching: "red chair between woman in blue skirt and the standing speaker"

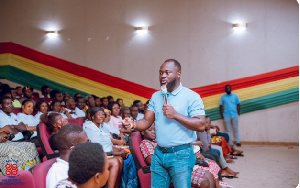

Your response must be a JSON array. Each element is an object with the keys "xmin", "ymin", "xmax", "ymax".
[{"xmin": 129, "ymin": 131, "xmax": 151, "ymax": 188}]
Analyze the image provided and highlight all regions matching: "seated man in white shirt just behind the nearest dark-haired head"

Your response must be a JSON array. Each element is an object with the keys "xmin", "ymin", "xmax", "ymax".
[{"xmin": 46, "ymin": 124, "xmax": 89, "ymax": 188}]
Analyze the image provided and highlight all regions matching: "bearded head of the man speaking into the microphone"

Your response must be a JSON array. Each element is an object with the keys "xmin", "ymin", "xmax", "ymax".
[{"xmin": 159, "ymin": 59, "xmax": 181, "ymax": 92}]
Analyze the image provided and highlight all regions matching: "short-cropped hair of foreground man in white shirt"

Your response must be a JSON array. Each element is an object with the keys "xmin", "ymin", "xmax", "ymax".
[{"xmin": 55, "ymin": 124, "xmax": 83, "ymax": 154}]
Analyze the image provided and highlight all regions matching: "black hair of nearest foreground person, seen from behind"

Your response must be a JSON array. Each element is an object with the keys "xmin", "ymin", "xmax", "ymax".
[{"xmin": 68, "ymin": 143, "xmax": 107, "ymax": 185}]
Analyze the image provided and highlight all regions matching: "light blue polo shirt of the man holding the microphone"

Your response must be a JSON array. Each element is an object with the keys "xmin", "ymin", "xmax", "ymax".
[{"xmin": 148, "ymin": 83, "xmax": 205, "ymax": 147}]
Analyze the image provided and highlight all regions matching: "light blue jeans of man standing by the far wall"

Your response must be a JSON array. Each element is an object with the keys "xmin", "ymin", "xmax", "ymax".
[{"xmin": 224, "ymin": 116, "xmax": 241, "ymax": 143}]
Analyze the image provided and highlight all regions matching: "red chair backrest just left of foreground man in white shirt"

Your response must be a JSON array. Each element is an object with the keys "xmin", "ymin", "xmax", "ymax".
[{"xmin": 37, "ymin": 122, "xmax": 58, "ymax": 159}]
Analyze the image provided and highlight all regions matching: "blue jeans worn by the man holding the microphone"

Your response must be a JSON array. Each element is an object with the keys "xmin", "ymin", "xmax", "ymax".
[{"xmin": 150, "ymin": 146, "xmax": 196, "ymax": 188}]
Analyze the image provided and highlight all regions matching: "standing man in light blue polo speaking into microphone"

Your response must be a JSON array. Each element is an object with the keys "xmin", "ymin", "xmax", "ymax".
[{"xmin": 123, "ymin": 59, "xmax": 205, "ymax": 188}]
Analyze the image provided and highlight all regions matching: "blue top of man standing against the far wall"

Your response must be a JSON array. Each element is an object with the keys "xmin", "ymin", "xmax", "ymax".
[{"xmin": 220, "ymin": 92, "xmax": 241, "ymax": 118}]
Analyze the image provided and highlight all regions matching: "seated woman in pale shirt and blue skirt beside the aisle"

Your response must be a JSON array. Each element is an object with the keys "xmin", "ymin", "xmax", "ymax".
[{"xmin": 83, "ymin": 107, "xmax": 137, "ymax": 187}]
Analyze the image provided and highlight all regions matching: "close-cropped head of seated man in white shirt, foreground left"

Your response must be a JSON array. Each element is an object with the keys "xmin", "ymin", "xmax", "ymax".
[{"xmin": 55, "ymin": 124, "xmax": 89, "ymax": 155}]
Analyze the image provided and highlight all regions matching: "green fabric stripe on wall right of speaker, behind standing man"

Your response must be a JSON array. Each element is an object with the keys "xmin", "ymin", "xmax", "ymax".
[{"xmin": 205, "ymin": 88, "xmax": 299, "ymax": 120}]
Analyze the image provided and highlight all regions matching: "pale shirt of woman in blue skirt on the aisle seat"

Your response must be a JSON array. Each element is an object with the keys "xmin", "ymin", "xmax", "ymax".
[{"xmin": 83, "ymin": 121, "xmax": 120, "ymax": 152}]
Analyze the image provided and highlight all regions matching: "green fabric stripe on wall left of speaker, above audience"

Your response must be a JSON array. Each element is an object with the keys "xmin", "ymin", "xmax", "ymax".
[{"xmin": 0, "ymin": 66, "xmax": 89, "ymax": 97}]
